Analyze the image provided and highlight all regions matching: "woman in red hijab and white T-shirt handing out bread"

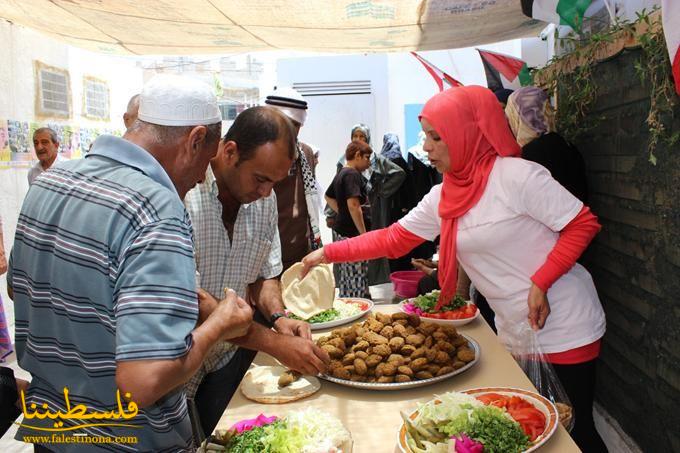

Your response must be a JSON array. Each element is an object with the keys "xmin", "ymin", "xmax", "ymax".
[{"xmin": 303, "ymin": 86, "xmax": 606, "ymax": 452}]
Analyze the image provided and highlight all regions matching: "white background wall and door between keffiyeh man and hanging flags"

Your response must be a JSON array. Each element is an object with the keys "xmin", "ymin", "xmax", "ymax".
[{"xmin": 277, "ymin": 38, "xmax": 547, "ymax": 192}]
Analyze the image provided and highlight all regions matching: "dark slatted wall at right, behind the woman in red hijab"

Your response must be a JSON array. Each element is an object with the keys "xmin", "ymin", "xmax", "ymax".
[{"xmin": 564, "ymin": 47, "xmax": 680, "ymax": 452}]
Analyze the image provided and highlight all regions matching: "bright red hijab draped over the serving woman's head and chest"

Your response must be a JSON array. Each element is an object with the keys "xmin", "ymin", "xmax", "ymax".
[{"xmin": 420, "ymin": 86, "xmax": 521, "ymax": 308}]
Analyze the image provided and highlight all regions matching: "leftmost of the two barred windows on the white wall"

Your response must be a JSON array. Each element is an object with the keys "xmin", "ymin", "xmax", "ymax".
[{"xmin": 35, "ymin": 61, "xmax": 71, "ymax": 118}]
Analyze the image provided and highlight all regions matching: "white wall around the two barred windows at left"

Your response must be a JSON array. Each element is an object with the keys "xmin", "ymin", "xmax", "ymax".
[{"xmin": 0, "ymin": 20, "xmax": 142, "ymax": 310}]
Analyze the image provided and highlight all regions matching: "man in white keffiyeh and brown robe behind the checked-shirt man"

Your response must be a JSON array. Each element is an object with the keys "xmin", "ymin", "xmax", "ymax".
[{"xmin": 264, "ymin": 88, "xmax": 321, "ymax": 271}]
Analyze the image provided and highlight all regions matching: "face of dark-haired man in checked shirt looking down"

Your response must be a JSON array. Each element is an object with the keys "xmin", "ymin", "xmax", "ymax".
[{"xmin": 220, "ymin": 139, "xmax": 293, "ymax": 203}]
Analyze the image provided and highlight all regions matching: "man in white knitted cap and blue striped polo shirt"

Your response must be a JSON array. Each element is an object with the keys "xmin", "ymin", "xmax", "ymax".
[{"xmin": 7, "ymin": 72, "xmax": 252, "ymax": 451}]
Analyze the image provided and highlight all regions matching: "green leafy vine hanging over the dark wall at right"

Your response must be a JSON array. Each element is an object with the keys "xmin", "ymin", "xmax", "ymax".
[{"xmin": 533, "ymin": 9, "xmax": 680, "ymax": 165}]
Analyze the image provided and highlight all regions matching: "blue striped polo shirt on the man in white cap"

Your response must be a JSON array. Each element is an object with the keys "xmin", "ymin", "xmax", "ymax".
[{"xmin": 7, "ymin": 136, "xmax": 198, "ymax": 452}]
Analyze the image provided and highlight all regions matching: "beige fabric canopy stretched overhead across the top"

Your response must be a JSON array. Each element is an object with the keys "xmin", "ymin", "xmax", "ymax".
[{"xmin": 0, "ymin": 0, "xmax": 545, "ymax": 55}]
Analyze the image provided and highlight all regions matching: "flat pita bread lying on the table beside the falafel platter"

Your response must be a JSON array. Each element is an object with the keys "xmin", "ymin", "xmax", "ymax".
[{"xmin": 241, "ymin": 366, "xmax": 321, "ymax": 404}]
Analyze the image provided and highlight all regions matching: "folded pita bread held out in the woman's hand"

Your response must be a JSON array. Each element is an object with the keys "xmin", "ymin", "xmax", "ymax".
[{"xmin": 281, "ymin": 263, "xmax": 335, "ymax": 319}]
